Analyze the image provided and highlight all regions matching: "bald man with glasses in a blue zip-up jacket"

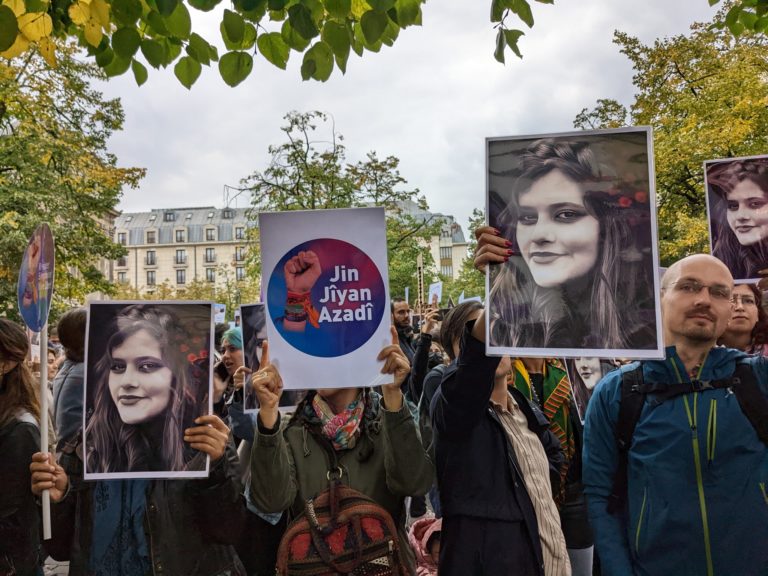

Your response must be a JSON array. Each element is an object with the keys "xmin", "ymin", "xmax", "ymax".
[{"xmin": 583, "ymin": 254, "xmax": 768, "ymax": 576}]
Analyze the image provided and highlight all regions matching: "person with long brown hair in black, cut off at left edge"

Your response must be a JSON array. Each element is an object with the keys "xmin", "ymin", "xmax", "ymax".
[{"xmin": 0, "ymin": 318, "xmax": 45, "ymax": 576}]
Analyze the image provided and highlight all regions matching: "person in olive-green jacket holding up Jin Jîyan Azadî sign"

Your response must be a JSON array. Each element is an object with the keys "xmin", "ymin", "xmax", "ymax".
[{"xmin": 250, "ymin": 328, "xmax": 434, "ymax": 573}]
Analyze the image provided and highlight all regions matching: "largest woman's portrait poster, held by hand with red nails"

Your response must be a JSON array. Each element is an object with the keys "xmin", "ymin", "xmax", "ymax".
[{"xmin": 486, "ymin": 128, "xmax": 664, "ymax": 358}]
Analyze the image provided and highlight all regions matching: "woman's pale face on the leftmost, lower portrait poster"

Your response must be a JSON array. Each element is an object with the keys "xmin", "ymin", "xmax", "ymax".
[{"xmin": 109, "ymin": 330, "xmax": 173, "ymax": 424}]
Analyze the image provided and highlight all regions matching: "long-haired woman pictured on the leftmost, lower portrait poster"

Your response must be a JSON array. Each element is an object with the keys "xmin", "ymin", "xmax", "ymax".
[{"xmin": 86, "ymin": 305, "xmax": 208, "ymax": 473}]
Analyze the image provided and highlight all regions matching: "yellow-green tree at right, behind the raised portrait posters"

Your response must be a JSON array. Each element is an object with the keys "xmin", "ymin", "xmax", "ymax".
[{"xmin": 575, "ymin": 7, "xmax": 768, "ymax": 265}]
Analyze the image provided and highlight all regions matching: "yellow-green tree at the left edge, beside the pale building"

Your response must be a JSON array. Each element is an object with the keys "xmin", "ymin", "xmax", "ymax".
[{"xmin": 0, "ymin": 45, "xmax": 144, "ymax": 318}]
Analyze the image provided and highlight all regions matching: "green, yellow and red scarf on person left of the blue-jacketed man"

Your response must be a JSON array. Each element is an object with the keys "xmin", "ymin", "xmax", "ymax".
[{"xmin": 507, "ymin": 358, "xmax": 576, "ymax": 504}]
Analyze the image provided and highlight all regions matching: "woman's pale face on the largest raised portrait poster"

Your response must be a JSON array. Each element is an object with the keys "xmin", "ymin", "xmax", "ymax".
[{"xmin": 516, "ymin": 170, "xmax": 600, "ymax": 288}]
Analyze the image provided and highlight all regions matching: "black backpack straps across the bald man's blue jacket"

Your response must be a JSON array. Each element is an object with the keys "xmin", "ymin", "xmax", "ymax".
[{"xmin": 608, "ymin": 363, "xmax": 768, "ymax": 514}]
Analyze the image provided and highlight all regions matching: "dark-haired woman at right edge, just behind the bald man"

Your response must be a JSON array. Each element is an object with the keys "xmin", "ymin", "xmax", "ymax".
[{"xmin": 717, "ymin": 284, "xmax": 768, "ymax": 354}]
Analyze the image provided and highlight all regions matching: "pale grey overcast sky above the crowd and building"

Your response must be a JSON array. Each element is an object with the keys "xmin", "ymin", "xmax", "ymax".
[{"xmin": 102, "ymin": 0, "xmax": 714, "ymax": 231}]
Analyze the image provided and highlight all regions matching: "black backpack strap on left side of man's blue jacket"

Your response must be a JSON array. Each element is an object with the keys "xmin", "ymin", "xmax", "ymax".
[{"xmin": 608, "ymin": 364, "xmax": 645, "ymax": 514}]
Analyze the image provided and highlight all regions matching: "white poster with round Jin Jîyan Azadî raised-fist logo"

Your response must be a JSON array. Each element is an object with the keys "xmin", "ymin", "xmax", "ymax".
[{"xmin": 259, "ymin": 208, "xmax": 392, "ymax": 390}]
